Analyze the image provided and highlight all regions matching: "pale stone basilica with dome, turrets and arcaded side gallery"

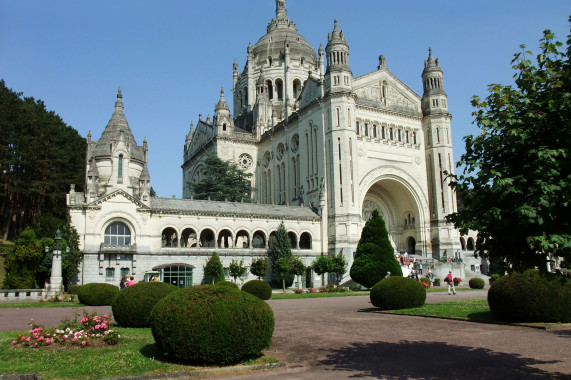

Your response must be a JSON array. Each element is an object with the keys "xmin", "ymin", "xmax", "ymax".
[{"xmin": 67, "ymin": 0, "xmax": 479, "ymax": 287}]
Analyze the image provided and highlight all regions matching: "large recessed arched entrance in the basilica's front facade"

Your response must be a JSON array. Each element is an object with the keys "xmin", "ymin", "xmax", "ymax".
[{"xmin": 362, "ymin": 177, "xmax": 426, "ymax": 255}]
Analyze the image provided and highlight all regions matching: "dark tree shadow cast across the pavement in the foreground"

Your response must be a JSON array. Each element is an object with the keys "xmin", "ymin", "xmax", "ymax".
[{"xmin": 318, "ymin": 341, "xmax": 570, "ymax": 380}]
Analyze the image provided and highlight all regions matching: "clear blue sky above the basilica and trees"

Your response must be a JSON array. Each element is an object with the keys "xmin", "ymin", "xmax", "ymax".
[{"xmin": 0, "ymin": 0, "xmax": 571, "ymax": 197}]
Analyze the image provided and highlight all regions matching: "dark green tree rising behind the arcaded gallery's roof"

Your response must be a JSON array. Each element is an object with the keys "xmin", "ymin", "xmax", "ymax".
[{"xmin": 187, "ymin": 152, "xmax": 252, "ymax": 202}]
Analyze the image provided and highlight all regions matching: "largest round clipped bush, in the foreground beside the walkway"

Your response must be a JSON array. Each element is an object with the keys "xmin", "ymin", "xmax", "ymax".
[{"xmin": 151, "ymin": 286, "xmax": 274, "ymax": 365}]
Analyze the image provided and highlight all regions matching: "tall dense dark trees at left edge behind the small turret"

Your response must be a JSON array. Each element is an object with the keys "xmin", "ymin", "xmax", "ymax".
[{"xmin": 0, "ymin": 80, "xmax": 87, "ymax": 239}]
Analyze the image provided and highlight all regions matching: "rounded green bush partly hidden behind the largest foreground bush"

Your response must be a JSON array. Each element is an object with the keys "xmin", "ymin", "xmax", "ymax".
[{"xmin": 111, "ymin": 281, "xmax": 178, "ymax": 327}]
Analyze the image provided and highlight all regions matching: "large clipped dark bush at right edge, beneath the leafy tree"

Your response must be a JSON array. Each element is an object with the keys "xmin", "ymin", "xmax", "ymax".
[{"xmin": 488, "ymin": 269, "xmax": 571, "ymax": 323}]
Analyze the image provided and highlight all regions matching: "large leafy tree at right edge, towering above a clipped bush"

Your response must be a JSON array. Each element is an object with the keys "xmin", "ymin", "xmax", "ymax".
[{"xmin": 447, "ymin": 23, "xmax": 571, "ymax": 271}]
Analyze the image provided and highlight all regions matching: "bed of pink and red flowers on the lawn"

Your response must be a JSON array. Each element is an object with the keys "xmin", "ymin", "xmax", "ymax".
[{"xmin": 12, "ymin": 313, "xmax": 121, "ymax": 348}]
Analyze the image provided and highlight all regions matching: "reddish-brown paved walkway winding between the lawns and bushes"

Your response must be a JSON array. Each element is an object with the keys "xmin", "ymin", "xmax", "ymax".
[{"xmin": 0, "ymin": 291, "xmax": 571, "ymax": 380}]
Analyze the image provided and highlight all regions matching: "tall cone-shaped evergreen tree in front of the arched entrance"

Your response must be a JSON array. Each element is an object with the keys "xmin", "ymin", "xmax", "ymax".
[{"xmin": 350, "ymin": 210, "xmax": 402, "ymax": 288}]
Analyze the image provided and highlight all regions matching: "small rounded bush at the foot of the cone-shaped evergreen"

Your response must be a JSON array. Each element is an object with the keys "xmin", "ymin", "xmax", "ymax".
[{"xmin": 370, "ymin": 277, "xmax": 426, "ymax": 310}]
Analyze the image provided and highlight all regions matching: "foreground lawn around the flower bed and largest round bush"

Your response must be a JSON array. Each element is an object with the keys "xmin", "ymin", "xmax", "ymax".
[{"xmin": 0, "ymin": 327, "xmax": 277, "ymax": 379}]
